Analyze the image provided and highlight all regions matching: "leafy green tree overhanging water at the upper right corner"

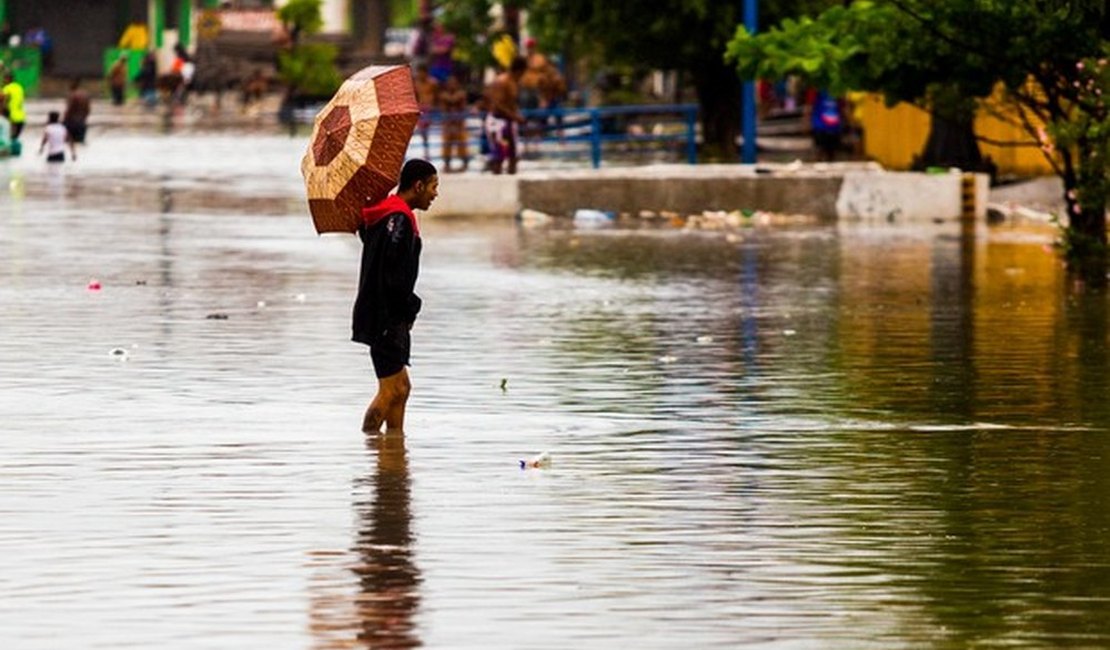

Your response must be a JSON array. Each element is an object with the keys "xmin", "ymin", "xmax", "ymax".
[{"xmin": 728, "ymin": 0, "xmax": 1110, "ymax": 285}]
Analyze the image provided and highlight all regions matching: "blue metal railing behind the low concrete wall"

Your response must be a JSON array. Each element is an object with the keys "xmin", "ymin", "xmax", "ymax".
[{"xmin": 399, "ymin": 104, "xmax": 697, "ymax": 169}]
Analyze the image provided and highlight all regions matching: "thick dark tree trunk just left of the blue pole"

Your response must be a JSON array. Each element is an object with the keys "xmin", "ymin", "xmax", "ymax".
[{"xmin": 689, "ymin": 57, "xmax": 740, "ymax": 162}]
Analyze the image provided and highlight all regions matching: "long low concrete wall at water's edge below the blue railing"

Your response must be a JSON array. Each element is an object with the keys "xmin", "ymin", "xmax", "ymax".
[{"xmin": 428, "ymin": 163, "xmax": 986, "ymax": 222}]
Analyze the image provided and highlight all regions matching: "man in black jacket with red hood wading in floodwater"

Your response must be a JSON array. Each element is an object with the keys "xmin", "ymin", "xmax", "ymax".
[{"xmin": 352, "ymin": 159, "xmax": 440, "ymax": 434}]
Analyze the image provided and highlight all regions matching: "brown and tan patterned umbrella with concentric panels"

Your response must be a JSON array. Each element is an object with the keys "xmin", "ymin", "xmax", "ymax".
[{"xmin": 301, "ymin": 65, "xmax": 420, "ymax": 233}]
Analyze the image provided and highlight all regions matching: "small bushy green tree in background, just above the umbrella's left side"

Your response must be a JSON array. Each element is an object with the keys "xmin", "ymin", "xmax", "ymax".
[{"xmin": 278, "ymin": 0, "xmax": 342, "ymax": 97}]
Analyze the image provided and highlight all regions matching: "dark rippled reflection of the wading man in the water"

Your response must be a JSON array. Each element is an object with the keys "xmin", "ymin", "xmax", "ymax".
[{"xmin": 354, "ymin": 433, "xmax": 421, "ymax": 648}]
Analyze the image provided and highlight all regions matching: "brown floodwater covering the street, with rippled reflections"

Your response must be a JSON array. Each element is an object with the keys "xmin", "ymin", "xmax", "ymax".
[{"xmin": 0, "ymin": 130, "xmax": 1110, "ymax": 649}]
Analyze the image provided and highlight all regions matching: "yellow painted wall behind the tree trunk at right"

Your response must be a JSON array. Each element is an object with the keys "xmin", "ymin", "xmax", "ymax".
[{"xmin": 857, "ymin": 87, "xmax": 1053, "ymax": 176}]
